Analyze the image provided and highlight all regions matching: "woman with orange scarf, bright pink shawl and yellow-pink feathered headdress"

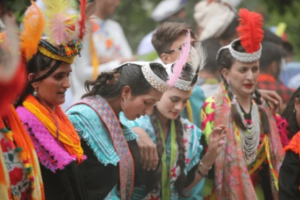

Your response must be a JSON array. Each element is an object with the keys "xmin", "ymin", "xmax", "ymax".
[{"xmin": 17, "ymin": 0, "xmax": 87, "ymax": 200}]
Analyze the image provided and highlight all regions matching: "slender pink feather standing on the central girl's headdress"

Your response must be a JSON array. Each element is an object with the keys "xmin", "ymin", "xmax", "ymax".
[{"xmin": 168, "ymin": 31, "xmax": 191, "ymax": 87}]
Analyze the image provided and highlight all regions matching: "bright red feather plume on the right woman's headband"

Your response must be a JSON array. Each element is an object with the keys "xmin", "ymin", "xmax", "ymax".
[{"xmin": 237, "ymin": 8, "xmax": 264, "ymax": 53}]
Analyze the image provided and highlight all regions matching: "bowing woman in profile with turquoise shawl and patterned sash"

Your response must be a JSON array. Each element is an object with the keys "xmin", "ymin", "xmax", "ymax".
[{"xmin": 67, "ymin": 62, "xmax": 168, "ymax": 200}]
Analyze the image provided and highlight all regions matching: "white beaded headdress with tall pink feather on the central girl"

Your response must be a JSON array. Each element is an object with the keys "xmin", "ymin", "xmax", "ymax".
[{"xmin": 166, "ymin": 31, "xmax": 206, "ymax": 91}]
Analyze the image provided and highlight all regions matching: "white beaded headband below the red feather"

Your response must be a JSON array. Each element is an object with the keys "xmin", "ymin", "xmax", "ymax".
[{"xmin": 217, "ymin": 39, "xmax": 262, "ymax": 63}]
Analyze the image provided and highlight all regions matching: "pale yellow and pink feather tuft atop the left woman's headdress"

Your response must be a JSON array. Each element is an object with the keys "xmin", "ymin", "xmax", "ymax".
[{"xmin": 43, "ymin": 0, "xmax": 79, "ymax": 46}]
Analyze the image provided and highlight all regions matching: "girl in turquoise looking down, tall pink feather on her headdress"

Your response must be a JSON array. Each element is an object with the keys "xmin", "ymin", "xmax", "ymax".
[{"xmin": 122, "ymin": 32, "xmax": 225, "ymax": 199}]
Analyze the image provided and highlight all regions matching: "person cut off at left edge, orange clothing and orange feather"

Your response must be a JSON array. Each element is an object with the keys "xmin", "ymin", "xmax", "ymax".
[{"xmin": 0, "ymin": 1, "xmax": 45, "ymax": 200}]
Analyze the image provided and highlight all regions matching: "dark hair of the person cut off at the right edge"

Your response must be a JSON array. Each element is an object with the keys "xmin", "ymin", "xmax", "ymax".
[{"xmin": 282, "ymin": 87, "xmax": 300, "ymax": 139}]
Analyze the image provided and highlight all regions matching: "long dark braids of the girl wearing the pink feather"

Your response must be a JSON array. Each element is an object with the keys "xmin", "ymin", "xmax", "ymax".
[{"xmin": 150, "ymin": 64, "xmax": 194, "ymax": 197}]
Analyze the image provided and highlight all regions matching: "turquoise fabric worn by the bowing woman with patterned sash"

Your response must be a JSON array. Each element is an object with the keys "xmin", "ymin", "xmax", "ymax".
[{"xmin": 66, "ymin": 104, "xmax": 137, "ymax": 200}]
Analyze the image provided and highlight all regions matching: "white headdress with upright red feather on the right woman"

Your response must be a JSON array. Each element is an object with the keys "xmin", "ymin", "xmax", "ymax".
[{"xmin": 217, "ymin": 8, "xmax": 264, "ymax": 63}]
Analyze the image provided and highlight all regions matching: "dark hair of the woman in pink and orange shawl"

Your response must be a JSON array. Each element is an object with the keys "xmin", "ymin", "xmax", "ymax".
[{"xmin": 15, "ymin": 51, "xmax": 62, "ymax": 107}]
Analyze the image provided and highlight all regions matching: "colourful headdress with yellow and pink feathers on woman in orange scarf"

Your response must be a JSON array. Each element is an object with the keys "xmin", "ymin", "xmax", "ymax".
[{"xmin": 34, "ymin": 0, "xmax": 86, "ymax": 64}]
